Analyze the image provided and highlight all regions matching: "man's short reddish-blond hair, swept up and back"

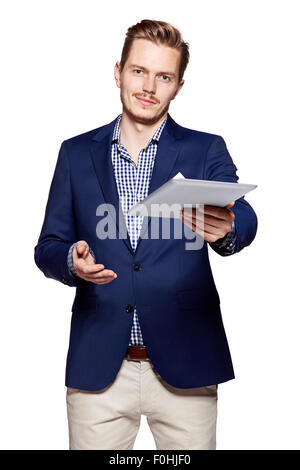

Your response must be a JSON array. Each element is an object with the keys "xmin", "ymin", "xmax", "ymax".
[{"xmin": 120, "ymin": 20, "xmax": 190, "ymax": 83}]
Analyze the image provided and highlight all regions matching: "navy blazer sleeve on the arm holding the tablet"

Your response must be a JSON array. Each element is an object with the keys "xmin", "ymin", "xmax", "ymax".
[{"xmin": 205, "ymin": 136, "xmax": 257, "ymax": 256}]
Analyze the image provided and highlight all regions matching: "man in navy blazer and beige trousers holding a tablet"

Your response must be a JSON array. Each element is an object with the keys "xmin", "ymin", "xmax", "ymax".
[{"xmin": 35, "ymin": 20, "xmax": 257, "ymax": 449}]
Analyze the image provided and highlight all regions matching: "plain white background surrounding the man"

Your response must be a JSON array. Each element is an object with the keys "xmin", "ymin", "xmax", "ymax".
[{"xmin": 0, "ymin": 0, "xmax": 300, "ymax": 450}]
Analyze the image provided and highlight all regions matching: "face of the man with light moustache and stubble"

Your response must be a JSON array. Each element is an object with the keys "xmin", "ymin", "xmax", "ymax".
[{"xmin": 115, "ymin": 39, "xmax": 184, "ymax": 125}]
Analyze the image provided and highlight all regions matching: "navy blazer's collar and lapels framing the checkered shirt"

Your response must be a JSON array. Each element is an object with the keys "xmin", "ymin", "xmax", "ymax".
[{"xmin": 90, "ymin": 113, "xmax": 183, "ymax": 255}]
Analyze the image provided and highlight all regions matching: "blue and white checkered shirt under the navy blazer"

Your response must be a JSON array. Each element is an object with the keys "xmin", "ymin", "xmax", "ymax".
[{"xmin": 67, "ymin": 114, "xmax": 236, "ymax": 346}]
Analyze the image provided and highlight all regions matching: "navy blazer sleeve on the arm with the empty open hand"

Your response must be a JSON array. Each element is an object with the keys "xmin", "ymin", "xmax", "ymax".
[{"xmin": 34, "ymin": 141, "xmax": 87, "ymax": 287}]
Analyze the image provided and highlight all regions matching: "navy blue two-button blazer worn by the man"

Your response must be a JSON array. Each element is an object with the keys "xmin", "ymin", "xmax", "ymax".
[{"xmin": 34, "ymin": 114, "xmax": 257, "ymax": 390}]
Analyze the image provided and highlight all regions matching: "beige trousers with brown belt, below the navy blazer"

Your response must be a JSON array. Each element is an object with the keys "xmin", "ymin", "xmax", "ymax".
[{"xmin": 66, "ymin": 359, "xmax": 218, "ymax": 450}]
